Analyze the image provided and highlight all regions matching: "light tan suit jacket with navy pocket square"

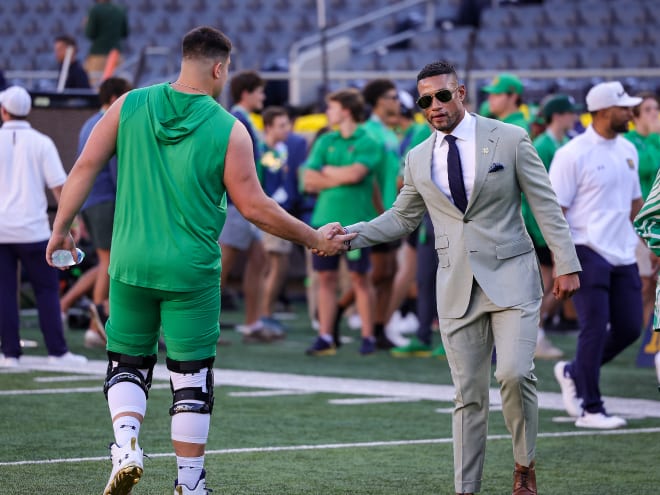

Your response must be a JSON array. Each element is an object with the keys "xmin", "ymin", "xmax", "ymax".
[{"xmin": 348, "ymin": 115, "xmax": 580, "ymax": 318}]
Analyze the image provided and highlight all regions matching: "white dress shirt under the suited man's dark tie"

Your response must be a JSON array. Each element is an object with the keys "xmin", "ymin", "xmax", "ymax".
[{"xmin": 431, "ymin": 111, "xmax": 477, "ymax": 206}]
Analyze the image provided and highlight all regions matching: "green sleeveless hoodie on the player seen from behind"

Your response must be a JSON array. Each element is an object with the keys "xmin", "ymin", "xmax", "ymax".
[{"xmin": 109, "ymin": 83, "xmax": 236, "ymax": 292}]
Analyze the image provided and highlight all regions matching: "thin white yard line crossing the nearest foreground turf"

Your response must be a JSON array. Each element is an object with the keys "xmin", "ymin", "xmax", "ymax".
[{"xmin": 0, "ymin": 428, "xmax": 660, "ymax": 467}]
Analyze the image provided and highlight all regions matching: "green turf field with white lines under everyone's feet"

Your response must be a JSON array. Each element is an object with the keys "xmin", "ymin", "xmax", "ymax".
[{"xmin": 0, "ymin": 307, "xmax": 660, "ymax": 495}]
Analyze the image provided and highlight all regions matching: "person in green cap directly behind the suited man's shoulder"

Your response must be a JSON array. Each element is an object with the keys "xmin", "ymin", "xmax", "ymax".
[{"xmin": 481, "ymin": 73, "xmax": 529, "ymax": 132}]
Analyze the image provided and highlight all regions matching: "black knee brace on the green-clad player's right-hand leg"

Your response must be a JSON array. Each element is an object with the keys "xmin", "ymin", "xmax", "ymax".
[{"xmin": 167, "ymin": 357, "xmax": 215, "ymax": 416}]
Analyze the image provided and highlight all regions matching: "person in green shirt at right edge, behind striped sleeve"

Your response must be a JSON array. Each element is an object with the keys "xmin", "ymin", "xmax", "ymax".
[{"xmin": 623, "ymin": 92, "xmax": 660, "ymax": 334}]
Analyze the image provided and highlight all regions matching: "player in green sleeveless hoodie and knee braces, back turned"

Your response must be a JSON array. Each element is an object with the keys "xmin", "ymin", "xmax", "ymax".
[{"xmin": 46, "ymin": 27, "xmax": 352, "ymax": 495}]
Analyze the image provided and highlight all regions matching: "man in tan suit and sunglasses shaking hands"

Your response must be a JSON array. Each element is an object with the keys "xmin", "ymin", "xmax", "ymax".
[{"xmin": 347, "ymin": 62, "xmax": 580, "ymax": 495}]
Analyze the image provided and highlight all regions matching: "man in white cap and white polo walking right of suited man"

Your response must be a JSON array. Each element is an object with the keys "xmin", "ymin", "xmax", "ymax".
[{"xmin": 550, "ymin": 81, "xmax": 642, "ymax": 429}]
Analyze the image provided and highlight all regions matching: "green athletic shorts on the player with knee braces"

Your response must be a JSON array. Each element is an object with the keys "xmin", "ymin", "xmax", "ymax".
[{"xmin": 106, "ymin": 278, "xmax": 220, "ymax": 361}]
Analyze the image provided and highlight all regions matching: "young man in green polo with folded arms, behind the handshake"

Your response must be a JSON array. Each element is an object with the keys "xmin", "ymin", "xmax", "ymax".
[{"xmin": 302, "ymin": 89, "xmax": 383, "ymax": 356}]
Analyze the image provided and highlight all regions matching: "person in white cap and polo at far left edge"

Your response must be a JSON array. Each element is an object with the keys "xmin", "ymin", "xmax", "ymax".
[{"xmin": 0, "ymin": 86, "xmax": 87, "ymax": 367}]
